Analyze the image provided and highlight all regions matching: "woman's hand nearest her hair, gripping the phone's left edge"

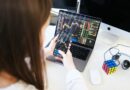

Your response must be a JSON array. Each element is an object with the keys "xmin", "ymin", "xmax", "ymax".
[{"xmin": 44, "ymin": 35, "xmax": 58, "ymax": 57}]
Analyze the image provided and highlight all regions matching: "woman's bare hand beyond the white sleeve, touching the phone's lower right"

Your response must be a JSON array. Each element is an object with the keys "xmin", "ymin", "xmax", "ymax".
[{"xmin": 59, "ymin": 49, "xmax": 76, "ymax": 70}]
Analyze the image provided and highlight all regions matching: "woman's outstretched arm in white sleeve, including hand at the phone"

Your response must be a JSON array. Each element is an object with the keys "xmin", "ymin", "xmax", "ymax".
[{"xmin": 59, "ymin": 50, "xmax": 88, "ymax": 90}]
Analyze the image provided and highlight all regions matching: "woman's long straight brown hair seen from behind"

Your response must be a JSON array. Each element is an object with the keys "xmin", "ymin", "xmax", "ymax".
[{"xmin": 0, "ymin": 0, "xmax": 51, "ymax": 90}]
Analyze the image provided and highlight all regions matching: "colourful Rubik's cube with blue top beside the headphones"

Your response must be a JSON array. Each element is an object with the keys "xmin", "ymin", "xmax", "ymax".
[{"xmin": 102, "ymin": 60, "xmax": 118, "ymax": 74}]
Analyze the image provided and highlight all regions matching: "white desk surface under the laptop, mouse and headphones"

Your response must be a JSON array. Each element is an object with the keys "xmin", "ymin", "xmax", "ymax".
[{"xmin": 45, "ymin": 23, "xmax": 130, "ymax": 90}]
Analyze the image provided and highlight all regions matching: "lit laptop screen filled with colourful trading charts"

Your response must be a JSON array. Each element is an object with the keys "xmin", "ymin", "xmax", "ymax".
[{"xmin": 55, "ymin": 10, "xmax": 101, "ymax": 48}]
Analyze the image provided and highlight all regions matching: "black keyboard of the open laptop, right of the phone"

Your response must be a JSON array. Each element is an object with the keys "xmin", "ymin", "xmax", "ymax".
[{"xmin": 70, "ymin": 45, "xmax": 90, "ymax": 60}]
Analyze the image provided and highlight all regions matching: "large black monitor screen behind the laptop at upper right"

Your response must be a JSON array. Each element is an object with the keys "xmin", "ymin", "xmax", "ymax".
[{"xmin": 80, "ymin": 0, "xmax": 130, "ymax": 32}]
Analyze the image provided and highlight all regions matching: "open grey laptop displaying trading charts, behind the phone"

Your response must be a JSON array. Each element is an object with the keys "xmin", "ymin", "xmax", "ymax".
[{"xmin": 47, "ymin": 10, "xmax": 101, "ymax": 72}]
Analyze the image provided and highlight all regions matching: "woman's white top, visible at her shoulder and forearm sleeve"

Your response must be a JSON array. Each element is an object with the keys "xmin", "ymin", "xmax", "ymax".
[{"xmin": 0, "ymin": 70, "xmax": 88, "ymax": 90}]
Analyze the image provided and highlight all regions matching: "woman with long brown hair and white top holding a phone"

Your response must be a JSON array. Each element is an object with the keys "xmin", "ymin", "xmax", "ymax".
[{"xmin": 0, "ymin": 0, "xmax": 86, "ymax": 90}]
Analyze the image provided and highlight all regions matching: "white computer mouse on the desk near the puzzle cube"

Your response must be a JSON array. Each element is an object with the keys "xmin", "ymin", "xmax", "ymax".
[{"xmin": 89, "ymin": 69, "xmax": 101, "ymax": 85}]
